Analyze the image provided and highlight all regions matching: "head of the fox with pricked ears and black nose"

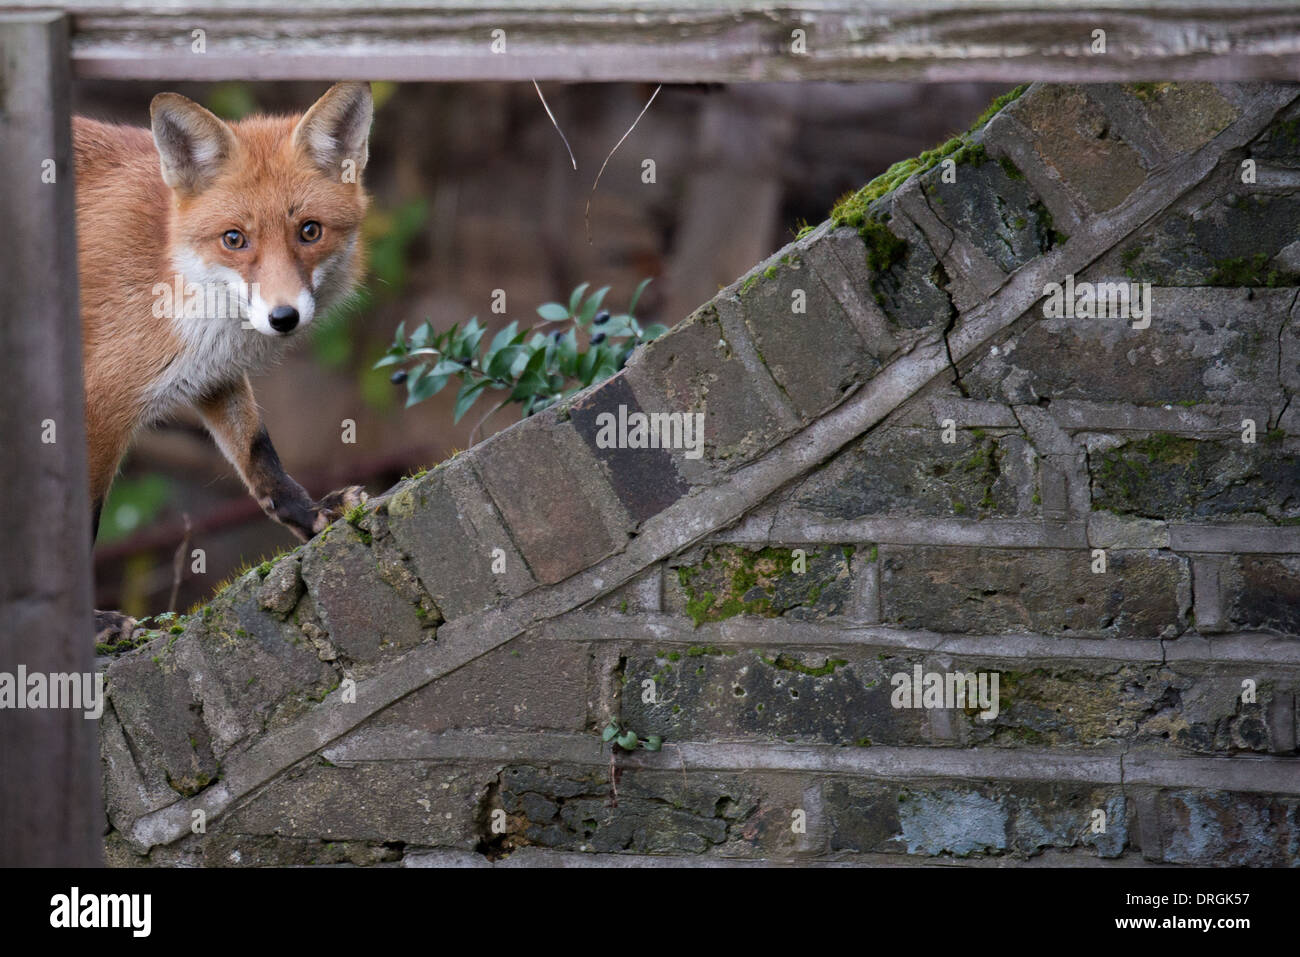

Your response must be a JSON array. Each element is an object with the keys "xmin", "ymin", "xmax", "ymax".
[{"xmin": 150, "ymin": 83, "xmax": 373, "ymax": 337}]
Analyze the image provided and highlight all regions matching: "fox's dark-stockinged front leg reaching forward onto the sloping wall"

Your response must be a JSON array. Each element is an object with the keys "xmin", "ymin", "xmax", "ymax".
[{"xmin": 196, "ymin": 376, "xmax": 365, "ymax": 541}]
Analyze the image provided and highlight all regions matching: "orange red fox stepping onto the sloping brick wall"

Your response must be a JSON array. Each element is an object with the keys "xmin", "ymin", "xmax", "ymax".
[{"xmin": 73, "ymin": 82, "xmax": 374, "ymax": 641}]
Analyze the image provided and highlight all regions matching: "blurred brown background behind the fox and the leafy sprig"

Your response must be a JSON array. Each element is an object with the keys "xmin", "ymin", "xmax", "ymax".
[{"xmin": 74, "ymin": 82, "xmax": 1005, "ymax": 616}]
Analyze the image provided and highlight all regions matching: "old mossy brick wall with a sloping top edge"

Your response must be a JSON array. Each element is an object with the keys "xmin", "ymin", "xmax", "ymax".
[{"xmin": 103, "ymin": 83, "xmax": 1300, "ymax": 866}]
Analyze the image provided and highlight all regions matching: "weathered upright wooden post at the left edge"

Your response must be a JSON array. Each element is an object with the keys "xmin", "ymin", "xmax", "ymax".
[{"xmin": 0, "ymin": 12, "xmax": 104, "ymax": 866}]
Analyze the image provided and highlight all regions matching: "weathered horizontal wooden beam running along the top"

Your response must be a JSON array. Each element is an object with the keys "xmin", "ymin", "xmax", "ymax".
[{"xmin": 0, "ymin": 0, "xmax": 1300, "ymax": 82}]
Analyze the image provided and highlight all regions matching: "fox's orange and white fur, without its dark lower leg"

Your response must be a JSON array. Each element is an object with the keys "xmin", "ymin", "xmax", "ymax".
[{"xmin": 73, "ymin": 85, "xmax": 369, "ymax": 533}]
